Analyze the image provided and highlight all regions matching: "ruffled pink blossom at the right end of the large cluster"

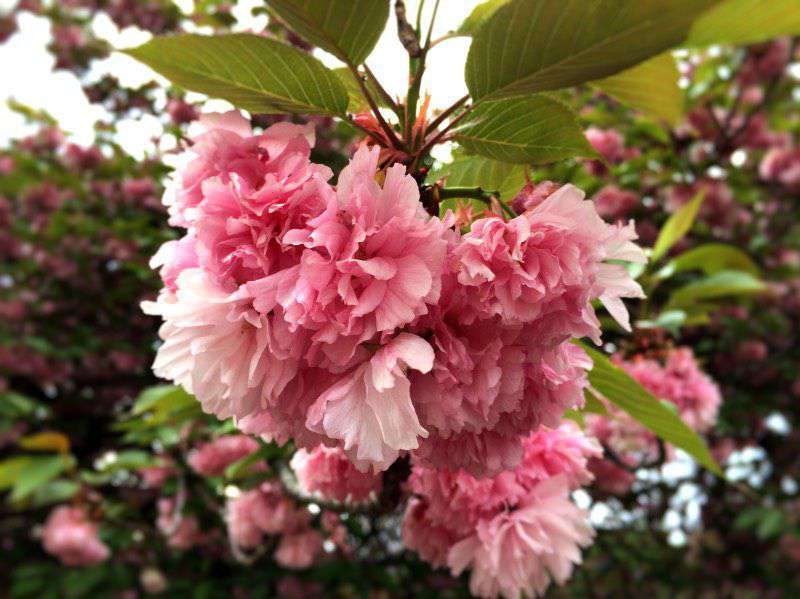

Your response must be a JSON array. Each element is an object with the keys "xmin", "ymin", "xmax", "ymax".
[{"xmin": 456, "ymin": 185, "xmax": 646, "ymax": 341}]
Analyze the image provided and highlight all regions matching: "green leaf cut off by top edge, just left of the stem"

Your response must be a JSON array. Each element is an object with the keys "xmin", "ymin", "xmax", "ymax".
[{"xmin": 268, "ymin": 0, "xmax": 389, "ymax": 65}]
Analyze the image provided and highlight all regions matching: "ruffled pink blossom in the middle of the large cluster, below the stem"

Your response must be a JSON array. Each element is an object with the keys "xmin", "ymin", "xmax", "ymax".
[{"xmin": 248, "ymin": 148, "xmax": 447, "ymax": 364}]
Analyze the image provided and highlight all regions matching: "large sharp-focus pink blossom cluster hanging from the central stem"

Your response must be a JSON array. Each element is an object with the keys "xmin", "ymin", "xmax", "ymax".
[{"xmin": 144, "ymin": 113, "xmax": 644, "ymax": 474}]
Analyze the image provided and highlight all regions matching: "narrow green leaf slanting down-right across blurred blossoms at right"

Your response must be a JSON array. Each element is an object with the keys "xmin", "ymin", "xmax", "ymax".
[{"xmin": 580, "ymin": 344, "xmax": 722, "ymax": 476}]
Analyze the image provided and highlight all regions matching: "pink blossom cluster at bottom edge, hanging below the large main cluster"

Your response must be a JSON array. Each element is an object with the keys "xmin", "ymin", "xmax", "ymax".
[{"xmin": 403, "ymin": 423, "xmax": 601, "ymax": 597}]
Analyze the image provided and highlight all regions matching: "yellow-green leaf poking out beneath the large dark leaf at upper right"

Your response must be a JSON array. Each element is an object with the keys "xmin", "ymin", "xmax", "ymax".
[{"xmin": 592, "ymin": 52, "xmax": 683, "ymax": 125}]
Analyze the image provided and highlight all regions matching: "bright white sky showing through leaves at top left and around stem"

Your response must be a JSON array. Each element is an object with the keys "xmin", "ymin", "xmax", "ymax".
[{"xmin": 0, "ymin": 0, "xmax": 481, "ymax": 158}]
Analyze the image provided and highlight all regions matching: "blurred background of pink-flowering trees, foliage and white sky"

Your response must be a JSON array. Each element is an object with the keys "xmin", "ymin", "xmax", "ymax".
[{"xmin": 0, "ymin": 0, "xmax": 800, "ymax": 597}]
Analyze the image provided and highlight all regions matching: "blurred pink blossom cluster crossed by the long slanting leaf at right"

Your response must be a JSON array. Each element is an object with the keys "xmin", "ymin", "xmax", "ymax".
[{"xmin": 586, "ymin": 347, "xmax": 722, "ymax": 494}]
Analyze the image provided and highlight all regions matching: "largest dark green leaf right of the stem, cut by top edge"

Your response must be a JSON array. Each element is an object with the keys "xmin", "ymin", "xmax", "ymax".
[{"xmin": 465, "ymin": 0, "xmax": 714, "ymax": 100}]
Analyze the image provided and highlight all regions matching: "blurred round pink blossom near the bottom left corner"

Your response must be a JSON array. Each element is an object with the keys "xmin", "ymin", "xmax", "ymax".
[{"xmin": 42, "ymin": 505, "xmax": 111, "ymax": 566}]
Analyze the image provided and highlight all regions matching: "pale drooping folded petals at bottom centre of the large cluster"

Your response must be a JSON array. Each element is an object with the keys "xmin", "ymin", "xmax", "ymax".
[{"xmin": 306, "ymin": 333, "xmax": 433, "ymax": 470}]
